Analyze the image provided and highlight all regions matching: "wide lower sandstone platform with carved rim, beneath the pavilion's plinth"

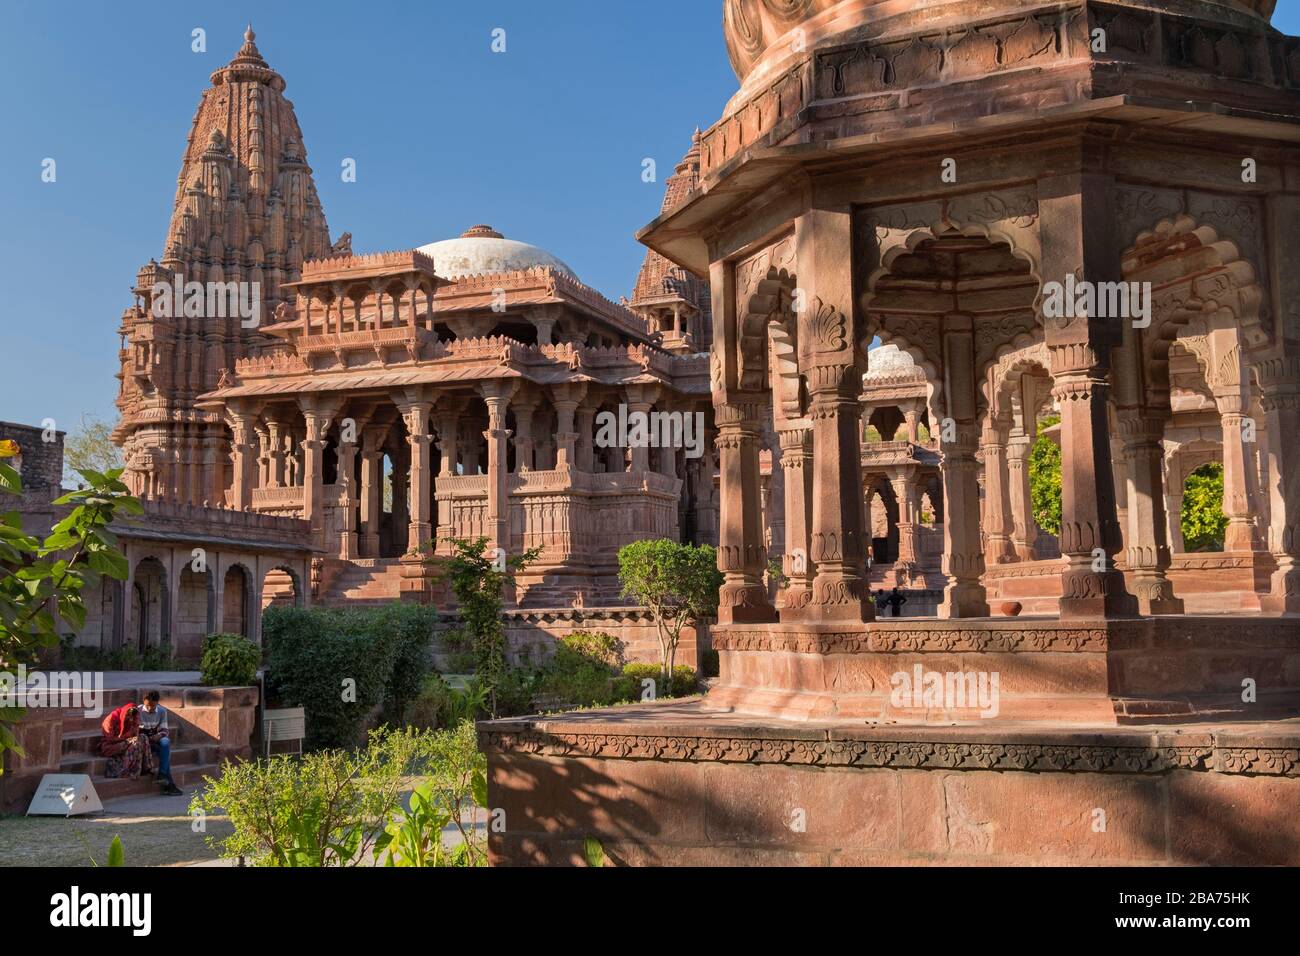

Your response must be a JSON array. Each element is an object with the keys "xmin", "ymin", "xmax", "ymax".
[{"xmin": 480, "ymin": 698, "xmax": 1300, "ymax": 866}]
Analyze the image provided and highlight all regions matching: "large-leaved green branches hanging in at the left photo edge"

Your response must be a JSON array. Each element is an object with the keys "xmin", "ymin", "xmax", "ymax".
[{"xmin": 0, "ymin": 455, "xmax": 143, "ymax": 773}]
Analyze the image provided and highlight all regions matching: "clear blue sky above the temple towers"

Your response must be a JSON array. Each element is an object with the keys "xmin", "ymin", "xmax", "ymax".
[{"xmin": 0, "ymin": 0, "xmax": 1300, "ymax": 429}]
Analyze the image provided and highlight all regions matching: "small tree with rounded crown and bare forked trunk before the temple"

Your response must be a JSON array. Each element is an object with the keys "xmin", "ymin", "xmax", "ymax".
[{"xmin": 619, "ymin": 538, "xmax": 723, "ymax": 687}]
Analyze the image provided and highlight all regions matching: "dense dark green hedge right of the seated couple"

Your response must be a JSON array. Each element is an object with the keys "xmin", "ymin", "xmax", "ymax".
[{"xmin": 261, "ymin": 606, "xmax": 436, "ymax": 748}]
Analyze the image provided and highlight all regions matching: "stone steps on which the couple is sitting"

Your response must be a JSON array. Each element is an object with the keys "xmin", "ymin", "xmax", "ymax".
[{"xmin": 59, "ymin": 689, "xmax": 221, "ymax": 800}]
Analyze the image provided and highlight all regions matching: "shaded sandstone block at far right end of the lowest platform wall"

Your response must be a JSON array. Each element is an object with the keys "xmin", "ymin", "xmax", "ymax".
[{"xmin": 1169, "ymin": 773, "xmax": 1300, "ymax": 866}]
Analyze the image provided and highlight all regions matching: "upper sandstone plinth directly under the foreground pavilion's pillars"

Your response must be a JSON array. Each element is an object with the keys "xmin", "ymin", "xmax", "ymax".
[{"xmin": 710, "ymin": 618, "xmax": 1300, "ymax": 724}]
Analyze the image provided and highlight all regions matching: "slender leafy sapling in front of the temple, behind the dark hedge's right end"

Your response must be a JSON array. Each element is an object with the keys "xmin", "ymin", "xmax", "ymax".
[{"xmin": 446, "ymin": 537, "xmax": 541, "ymax": 717}]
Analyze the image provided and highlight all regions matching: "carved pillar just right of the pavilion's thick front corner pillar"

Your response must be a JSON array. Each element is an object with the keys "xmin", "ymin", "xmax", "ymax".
[{"xmin": 1119, "ymin": 410, "xmax": 1183, "ymax": 614}]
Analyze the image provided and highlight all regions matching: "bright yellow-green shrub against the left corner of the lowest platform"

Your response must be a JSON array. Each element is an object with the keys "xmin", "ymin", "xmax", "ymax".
[{"xmin": 374, "ymin": 721, "xmax": 488, "ymax": 866}]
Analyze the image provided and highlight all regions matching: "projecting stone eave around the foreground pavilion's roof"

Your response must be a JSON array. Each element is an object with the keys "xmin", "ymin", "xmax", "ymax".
[{"xmin": 637, "ymin": 94, "xmax": 1300, "ymax": 277}]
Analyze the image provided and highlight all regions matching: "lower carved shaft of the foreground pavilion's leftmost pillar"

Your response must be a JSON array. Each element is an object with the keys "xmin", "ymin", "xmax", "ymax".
[{"xmin": 715, "ymin": 401, "xmax": 776, "ymax": 624}]
